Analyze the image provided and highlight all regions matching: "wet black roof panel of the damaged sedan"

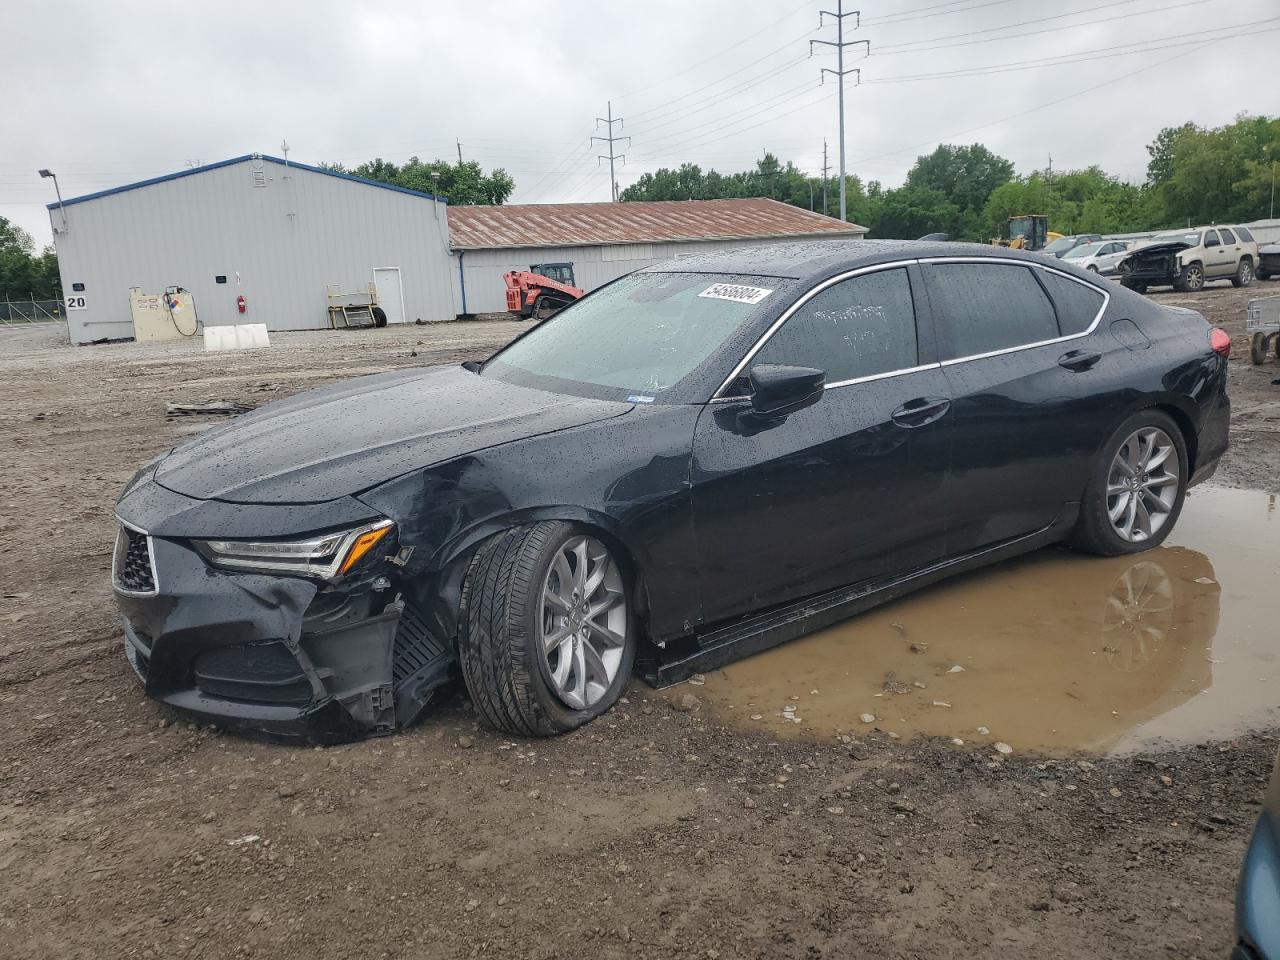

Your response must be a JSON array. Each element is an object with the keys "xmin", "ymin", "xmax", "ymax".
[{"xmin": 643, "ymin": 239, "xmax": 1044, "ymax": 280}]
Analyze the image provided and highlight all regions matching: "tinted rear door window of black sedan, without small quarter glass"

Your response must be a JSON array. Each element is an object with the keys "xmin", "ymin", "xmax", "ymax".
[{"xmin": 923, "ymin": 264, "xmax": 1059, "ymax": 360}]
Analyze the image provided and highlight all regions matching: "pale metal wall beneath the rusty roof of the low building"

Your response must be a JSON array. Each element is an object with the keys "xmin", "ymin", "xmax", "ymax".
[{"xmin": 454, "ymin": 237, "xmax": 847, "ymax": 314}]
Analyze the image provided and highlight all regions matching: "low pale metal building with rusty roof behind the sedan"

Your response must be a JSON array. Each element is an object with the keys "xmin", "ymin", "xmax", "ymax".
[{"xmin": 449, "ymin": 197, "xmax": 867, "ymax": 314}]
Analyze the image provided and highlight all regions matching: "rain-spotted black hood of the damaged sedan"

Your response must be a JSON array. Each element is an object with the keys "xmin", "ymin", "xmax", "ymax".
[{"xmin": 155, "ymin": 366, "xmax": 631, "ymax": 503}]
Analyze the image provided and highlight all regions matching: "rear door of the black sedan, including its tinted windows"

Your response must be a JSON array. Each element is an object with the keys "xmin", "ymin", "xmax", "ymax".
[{"xmin": 920, "ymin": 257, "xmax": 1108, "ymax": 556}]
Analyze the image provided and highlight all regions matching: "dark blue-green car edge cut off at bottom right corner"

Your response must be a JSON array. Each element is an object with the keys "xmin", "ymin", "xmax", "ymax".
[{"xmin": 1231, "ymin": 758, "xmax": 1280, "ymax": 960}]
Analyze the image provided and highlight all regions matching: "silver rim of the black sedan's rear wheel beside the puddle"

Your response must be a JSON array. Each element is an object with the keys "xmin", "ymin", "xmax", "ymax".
[{"xmin": 1107, "ymin": 426, "xmax": 1181, "ymax": 543}]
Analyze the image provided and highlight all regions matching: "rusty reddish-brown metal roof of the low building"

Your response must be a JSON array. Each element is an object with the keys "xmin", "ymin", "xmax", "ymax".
[{"xmin": 448, "ymin": 197, "xmax": 867, "ymax": 250}]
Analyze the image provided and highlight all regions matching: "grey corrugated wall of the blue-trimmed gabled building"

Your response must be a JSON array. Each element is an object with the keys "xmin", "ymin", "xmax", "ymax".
[{"xmin": 50, "ymin": 160, "xmax": 455, "ymax": 343}]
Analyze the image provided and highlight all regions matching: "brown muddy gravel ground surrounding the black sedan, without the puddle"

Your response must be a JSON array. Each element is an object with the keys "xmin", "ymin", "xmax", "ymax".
[{"xmin": 0, "ymin": 284, "xmax": 1280, "ymax": 959}]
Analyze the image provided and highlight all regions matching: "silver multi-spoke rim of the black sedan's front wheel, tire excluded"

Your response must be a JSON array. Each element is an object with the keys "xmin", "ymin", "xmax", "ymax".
[{"xmin": 539, "ymin": 536, "xmax": 630, "ymax": 710}]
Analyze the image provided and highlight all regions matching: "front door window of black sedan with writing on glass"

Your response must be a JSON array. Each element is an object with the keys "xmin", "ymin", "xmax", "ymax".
[{"xmin": 751, "ymin": 268, "xmax": 919, "ymax": 383}]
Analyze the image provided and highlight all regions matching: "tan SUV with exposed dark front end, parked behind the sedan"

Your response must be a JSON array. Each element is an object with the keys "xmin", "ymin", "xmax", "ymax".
[{"xmin": 1120, "ymin": 227, "xmax": 1258, "ymax": 293}]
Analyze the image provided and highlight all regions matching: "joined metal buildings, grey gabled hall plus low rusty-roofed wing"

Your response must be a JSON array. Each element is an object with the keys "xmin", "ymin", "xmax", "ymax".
[{"xmin": 49, "ymin": 154, "xmax": 865, "ymax": 343}]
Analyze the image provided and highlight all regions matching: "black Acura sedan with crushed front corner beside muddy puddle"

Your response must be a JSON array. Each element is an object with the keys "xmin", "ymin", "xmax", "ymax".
[{"xmin": 113, "ymin": 241, "xmax": 1230, "ymax": 741}]
